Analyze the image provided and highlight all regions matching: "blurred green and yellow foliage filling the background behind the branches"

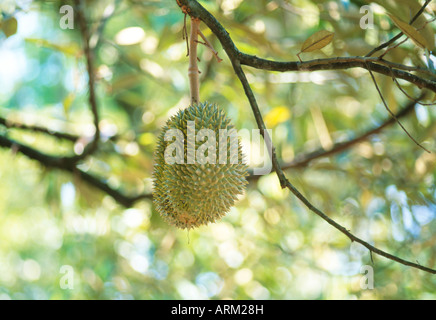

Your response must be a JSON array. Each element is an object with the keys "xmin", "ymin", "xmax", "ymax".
[{"xmin": 0, "ymin": 0, "xmax": 436, "ymax": 299}]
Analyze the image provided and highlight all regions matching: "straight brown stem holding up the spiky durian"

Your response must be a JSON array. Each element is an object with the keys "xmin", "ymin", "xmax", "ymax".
[{"xmin": 188, "ymin": 18, "xmax": 201, "ymax": 105}]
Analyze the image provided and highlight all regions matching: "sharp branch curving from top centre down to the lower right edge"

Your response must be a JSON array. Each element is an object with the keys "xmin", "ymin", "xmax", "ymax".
[{"xmin": 177, "ymin": 0, "xmax": 436, "ymax": 274}]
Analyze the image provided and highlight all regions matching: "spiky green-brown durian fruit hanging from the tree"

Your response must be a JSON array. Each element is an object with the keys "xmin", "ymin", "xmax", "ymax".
[{"xmin": 153, "ymin": 102, "xmax": 248, "ymax": 230}]
